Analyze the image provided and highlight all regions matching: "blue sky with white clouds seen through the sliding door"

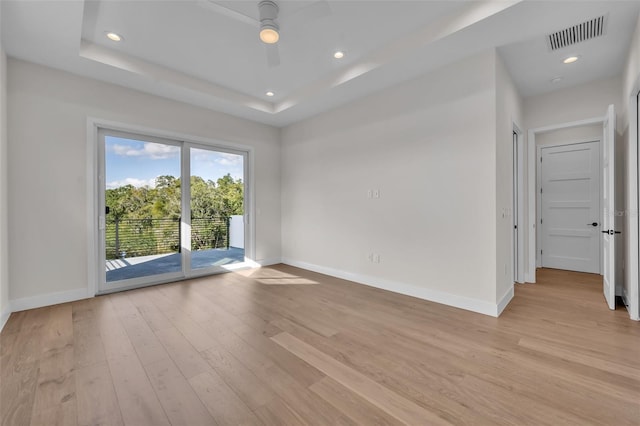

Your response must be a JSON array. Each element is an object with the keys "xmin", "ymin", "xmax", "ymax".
[{"xmin": 105, "ymin": 136, "xmax": 243, "ymax": 189}]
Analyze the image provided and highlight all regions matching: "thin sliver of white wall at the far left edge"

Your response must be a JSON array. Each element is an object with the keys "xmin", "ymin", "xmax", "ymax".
[{"xmin": 0, "ymin": 5, "xmax": 11, "ymax": 330}]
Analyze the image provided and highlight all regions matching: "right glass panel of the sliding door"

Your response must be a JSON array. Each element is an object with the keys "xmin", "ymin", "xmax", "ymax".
[{"xmin": 189, "ymin": 147, "xmax": 245, "ymax": 272}]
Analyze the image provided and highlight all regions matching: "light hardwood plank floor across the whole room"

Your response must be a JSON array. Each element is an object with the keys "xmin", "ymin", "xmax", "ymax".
[{"xmin": 0, "ymin": 265, "xmax": 640, "ymax": 426}]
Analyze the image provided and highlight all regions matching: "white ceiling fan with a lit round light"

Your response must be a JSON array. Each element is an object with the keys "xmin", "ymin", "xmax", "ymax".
[{"xmin": 199, "ymin": 0, "xmax": 331, "ymax": 68}]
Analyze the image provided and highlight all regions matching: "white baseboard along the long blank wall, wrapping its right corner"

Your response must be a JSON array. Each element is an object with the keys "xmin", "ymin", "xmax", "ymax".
[{"xmin": 282, "ymin": 258, "xmax": 513, "ymax": 317}]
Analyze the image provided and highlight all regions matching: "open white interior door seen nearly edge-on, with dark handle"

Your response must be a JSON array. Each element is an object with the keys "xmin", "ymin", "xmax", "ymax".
[{"xmin": 602, "ymin": 105, "xmax": 616, "ymax": 309}]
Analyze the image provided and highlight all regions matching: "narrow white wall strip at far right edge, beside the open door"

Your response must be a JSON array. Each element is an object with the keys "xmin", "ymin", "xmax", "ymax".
[{"xmin": 620, "ymin": 17, "xmax": 640, "ymax": 320}]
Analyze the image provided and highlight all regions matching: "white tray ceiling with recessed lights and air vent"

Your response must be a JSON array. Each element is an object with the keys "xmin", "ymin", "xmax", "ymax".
[{"xmin": 1, "ymin": 0, "xmax": 640, "ymax": 126}]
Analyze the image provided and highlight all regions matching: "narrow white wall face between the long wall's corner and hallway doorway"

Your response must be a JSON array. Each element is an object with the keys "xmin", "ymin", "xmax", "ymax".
[{"xmin": 496, "ymin": 55, "xmax": 526, "ymax": 305}]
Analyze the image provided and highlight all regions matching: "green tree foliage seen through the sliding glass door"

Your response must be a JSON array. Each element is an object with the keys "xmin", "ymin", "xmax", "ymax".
[{"xmin": 105, "ymin": 174, "xmax": 244, "ymax": 259}]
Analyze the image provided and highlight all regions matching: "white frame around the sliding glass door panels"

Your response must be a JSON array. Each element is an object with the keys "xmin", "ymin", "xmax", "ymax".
[{"xmin": 86, "ymin": 117, "xmax": 256, "ymax": 295}]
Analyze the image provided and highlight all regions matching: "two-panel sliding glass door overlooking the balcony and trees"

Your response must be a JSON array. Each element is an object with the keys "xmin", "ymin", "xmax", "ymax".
[{"xmin": 98, "ymin": 129, "xmax": 247, "ymax": 293}]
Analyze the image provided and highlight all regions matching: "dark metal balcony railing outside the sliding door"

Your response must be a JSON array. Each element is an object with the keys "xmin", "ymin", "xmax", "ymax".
[{"xmin": 105, "ymin": 217, "xmax": 229, "ymax": 259}]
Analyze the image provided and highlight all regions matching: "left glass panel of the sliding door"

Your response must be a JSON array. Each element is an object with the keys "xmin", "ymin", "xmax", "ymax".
[{"xmin": 102, "ymin": 132, "xmax": 183, "ymax": 291}]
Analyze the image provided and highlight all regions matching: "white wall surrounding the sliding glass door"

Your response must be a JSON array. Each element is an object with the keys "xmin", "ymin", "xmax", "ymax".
[{"xmin": 8, "ymin": 59, "xmax": 280, "ymax": 306}]
